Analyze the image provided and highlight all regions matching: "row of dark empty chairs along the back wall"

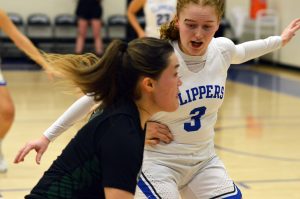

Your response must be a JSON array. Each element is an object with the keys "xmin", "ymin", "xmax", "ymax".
[{"xmin": 0, "ymin": 13, "xmax": 133, "ymax": 57}]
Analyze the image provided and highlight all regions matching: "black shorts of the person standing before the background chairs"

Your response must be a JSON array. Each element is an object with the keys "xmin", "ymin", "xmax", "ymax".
[{"xmin": 76, "ymin": 0, "xmax": 102, "ymax": 20}]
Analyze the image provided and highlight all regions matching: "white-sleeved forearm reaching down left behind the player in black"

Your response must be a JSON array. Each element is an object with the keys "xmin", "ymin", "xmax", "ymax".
[{"xmin": 44, "ymin": 95, "xmax": 96, "ymax": 141}]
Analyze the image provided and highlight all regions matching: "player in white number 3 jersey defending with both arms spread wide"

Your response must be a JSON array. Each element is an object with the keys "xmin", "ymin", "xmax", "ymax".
[{"xmin": 16, "ymin": 0, "xmax": 300, "ymax": 199}]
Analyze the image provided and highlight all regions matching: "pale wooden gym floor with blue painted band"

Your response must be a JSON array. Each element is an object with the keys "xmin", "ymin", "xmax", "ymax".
[{"xmin": 0, "ymin": 65, "xmax": 300, "ymax": 199}]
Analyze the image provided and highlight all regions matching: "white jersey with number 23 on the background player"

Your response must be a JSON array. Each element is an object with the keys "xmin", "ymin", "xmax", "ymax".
[{"xmin": 144, "ymin": 0, "xmax": 177, "ymax": 38}]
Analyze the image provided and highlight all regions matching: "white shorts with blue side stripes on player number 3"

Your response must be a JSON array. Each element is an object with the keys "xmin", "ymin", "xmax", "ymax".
[{"xmin": 135, "ymin": 152, "xmax": 242, "ymax": 199}]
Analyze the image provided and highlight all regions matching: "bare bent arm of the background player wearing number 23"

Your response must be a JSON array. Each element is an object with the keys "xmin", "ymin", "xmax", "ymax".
[{"xmin": 127, "ymin": 0, "xmax": 146, "ymax": 38}]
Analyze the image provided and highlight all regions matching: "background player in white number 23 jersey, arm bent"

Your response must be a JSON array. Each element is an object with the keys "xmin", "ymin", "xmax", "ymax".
[{"xmin": 127, "ymin": 0, "xmax": 177, "ymax": 38}]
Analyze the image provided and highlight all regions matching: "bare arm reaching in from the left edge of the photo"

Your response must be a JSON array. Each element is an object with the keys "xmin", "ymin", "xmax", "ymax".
[{"xmin": 0, "ymin": 10, "xmax": 47, "ymax": 69}]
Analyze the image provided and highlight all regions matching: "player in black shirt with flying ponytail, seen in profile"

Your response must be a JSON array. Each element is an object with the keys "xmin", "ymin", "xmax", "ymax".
[{"xmin": 25, "ymin": 38, "xmax": 181, "ymax": 199}]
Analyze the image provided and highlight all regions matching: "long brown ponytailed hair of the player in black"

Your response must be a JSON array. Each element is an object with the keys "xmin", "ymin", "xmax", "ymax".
[{"xmin": 44, "ymin": 38, "xmax": 173, "ymax": 107}]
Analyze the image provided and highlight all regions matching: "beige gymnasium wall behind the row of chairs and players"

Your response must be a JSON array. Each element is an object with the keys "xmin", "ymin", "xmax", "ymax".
[{"xmin": 0, "ymin": 0, "xmax": 300, "ymax": 68}]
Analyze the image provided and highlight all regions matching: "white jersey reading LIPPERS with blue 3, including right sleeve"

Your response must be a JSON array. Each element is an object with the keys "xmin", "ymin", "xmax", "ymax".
[{"xmin": 145, "ymin": 36, "xmax": 281, "ymax": 160}]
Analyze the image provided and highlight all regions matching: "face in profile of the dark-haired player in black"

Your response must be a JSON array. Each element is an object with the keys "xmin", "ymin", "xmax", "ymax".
[{"xmin": 153, "ymin": 53, "xmax": 182, "ymax": 112}]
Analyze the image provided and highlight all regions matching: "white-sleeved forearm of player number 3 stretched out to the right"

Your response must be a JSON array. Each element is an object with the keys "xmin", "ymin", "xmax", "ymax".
[{"xmin": 232, "ymin": 36, "xmax": 282, "ymax": 64}]
